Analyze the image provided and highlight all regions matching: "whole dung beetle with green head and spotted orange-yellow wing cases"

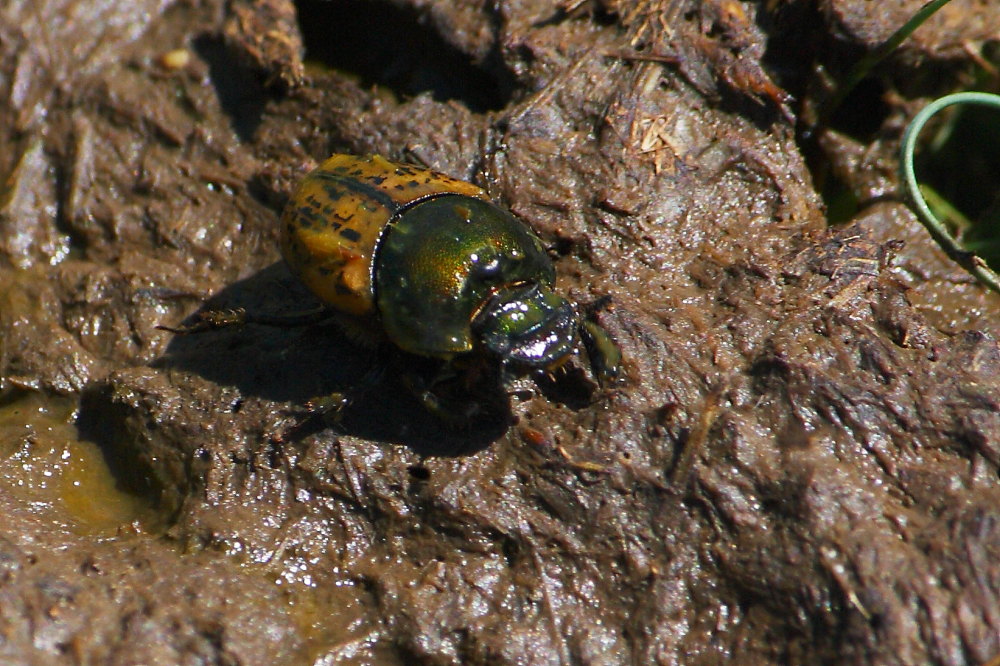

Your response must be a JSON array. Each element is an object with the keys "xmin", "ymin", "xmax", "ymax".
[{"xmin": 166, "ymin": 154, "xmax": 620, "ymax": 416}]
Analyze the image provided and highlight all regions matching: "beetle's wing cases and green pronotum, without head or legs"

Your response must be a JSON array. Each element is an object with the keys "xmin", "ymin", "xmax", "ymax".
[{"xmin": 281, "ymin": 155, "xmax": 555, "ymax": 358}]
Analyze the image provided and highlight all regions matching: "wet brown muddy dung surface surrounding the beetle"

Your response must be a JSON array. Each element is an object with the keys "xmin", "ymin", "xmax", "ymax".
[{"xmin": 0, "ymin": 0, "xmax": 1000, "ymax": 664}]
